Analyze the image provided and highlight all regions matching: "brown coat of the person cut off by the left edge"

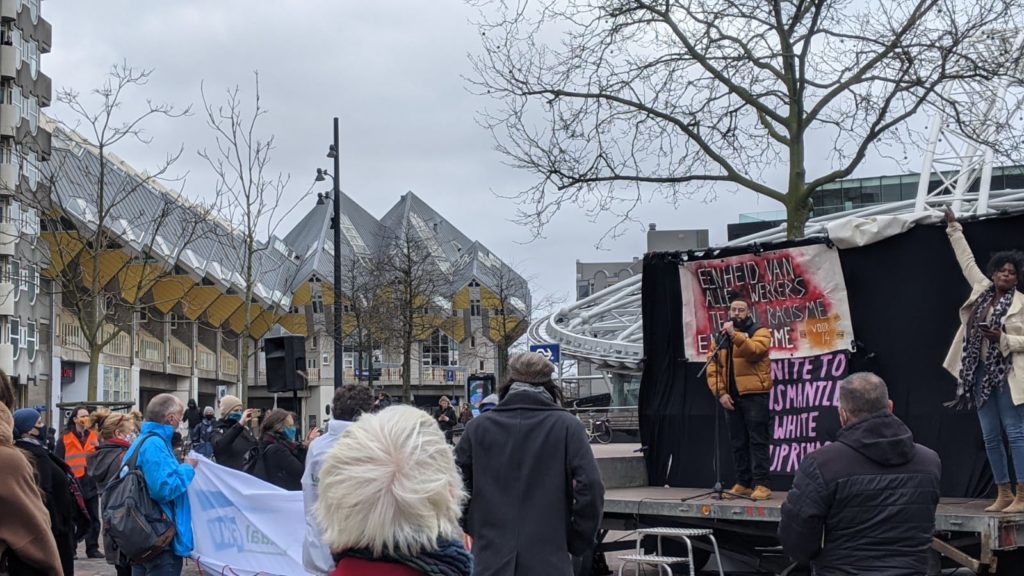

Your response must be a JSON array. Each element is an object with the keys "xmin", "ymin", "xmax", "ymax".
[{"xmin": 0, "ymin": 404, "xmax": 63, "ymax": 576}]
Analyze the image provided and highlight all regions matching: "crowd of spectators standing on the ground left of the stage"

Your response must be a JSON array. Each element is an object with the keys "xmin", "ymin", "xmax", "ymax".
[{"xmin": 0, "ymin": 353, "xmax": 604, "ymax": 576}]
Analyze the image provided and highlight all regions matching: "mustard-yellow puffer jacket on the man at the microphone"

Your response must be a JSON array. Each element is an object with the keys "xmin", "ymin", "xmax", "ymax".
[{"xmin": 708, "ymin": 328, "xmax": 771, "ymax": 398}]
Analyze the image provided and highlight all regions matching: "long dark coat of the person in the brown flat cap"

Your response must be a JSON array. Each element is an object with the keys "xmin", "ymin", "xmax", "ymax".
[{"xmin": 455, "ymin": 390, "xmax": 604, "ymax": 576}]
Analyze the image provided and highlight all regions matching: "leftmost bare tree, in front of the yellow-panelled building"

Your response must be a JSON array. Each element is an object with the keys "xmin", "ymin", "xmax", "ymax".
[{"xmin": 36, "ymin": 63, "xmax": 211, "ymax": 401}]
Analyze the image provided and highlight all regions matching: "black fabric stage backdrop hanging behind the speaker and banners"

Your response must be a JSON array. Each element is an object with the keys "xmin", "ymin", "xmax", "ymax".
[{"xmin": 639, "ymin": 216, "xmax": 1024, "ymax": 497}]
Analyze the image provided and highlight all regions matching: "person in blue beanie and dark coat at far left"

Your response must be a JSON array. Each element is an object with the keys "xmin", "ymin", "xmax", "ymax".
[{"xmin": 11, "ymin": 408, "xmax": 80, "ymax": 575}]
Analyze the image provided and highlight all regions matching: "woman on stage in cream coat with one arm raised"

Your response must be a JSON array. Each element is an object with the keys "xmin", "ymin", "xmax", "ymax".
[{"xmin": 943, "ymin": 207, "xmax": 1024, "ymax": 513}]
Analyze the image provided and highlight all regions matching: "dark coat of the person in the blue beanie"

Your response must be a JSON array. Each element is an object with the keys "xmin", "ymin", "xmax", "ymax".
[{"xmin": 11, "ymin": 439, "xmax": 80, "ymax": 574}]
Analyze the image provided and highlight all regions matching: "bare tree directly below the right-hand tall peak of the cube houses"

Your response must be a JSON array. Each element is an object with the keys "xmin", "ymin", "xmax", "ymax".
[{"xmin": 375, "ymin": 221, "xmax": 455, "ymax": 402}]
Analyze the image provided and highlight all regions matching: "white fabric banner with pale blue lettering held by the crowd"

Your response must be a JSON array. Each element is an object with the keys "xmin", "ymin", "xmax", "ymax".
[{"xmin": 188, "ymin": 453, "xmax": 308, "ymax": 576}]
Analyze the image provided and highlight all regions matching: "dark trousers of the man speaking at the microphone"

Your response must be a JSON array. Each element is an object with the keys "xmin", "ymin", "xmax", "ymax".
[{"xmin": 725, "ymin": 393, "xmax": 771, "ymax": 488}]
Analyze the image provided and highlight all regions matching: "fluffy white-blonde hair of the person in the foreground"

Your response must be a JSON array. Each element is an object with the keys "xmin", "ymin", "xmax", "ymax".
[{"xmin": 316, "ymin": 406, "xmax": 466, "ymax": 557}]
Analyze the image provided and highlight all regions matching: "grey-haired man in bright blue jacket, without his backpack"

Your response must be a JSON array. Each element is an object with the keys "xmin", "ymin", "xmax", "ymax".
[{"xmin": 122, "ymin": 394, "xmax": 199, "ymax": 576}]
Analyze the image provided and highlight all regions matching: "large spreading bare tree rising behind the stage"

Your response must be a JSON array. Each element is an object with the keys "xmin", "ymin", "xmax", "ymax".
[{"xmin": 470, "ymin": 0, "xmax": 1024, "ymax": 238}]
